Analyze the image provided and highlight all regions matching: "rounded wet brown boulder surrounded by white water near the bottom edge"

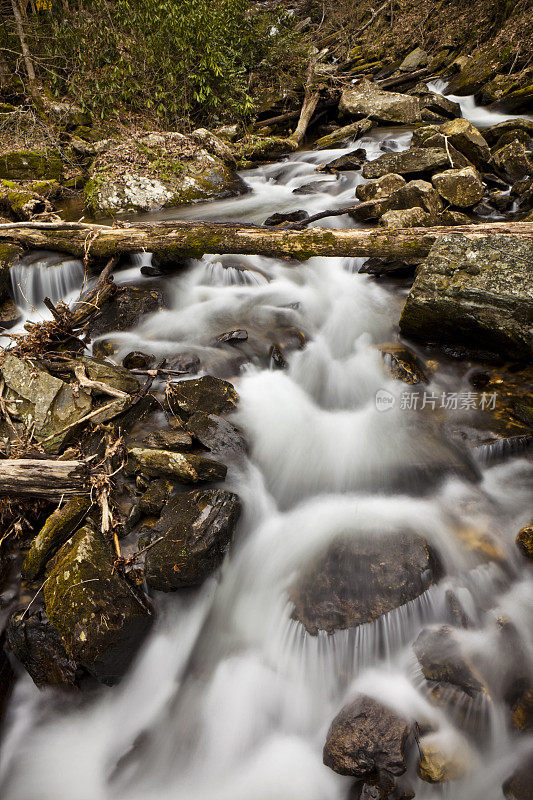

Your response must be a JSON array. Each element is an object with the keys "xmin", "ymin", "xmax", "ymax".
[{"xmin": 323, "ymin": 695, "xmax": 413, "ymax": 783}]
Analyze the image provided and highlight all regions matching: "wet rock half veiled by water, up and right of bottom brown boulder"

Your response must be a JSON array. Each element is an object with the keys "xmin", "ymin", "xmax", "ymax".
[{"xmin": 413, "ymin": 625, "xmax": 488, "ymax": 699}]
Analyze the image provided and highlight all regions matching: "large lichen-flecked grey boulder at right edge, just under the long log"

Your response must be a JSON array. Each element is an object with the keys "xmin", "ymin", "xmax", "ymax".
[{"xmin": 400, "ymin": 235, "xmax": 533, "ymax": 360}]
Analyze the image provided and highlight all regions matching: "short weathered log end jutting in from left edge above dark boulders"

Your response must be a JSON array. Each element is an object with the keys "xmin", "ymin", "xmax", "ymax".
[{"xmin": 0, "ymin": 458, "xmax": 90, "ymax": 500}]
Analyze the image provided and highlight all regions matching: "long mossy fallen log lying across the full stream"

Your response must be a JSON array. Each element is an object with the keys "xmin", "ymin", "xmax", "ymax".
[{"xmin": 0, "ymin": 220, "xmax": 533, "ymax": 261}]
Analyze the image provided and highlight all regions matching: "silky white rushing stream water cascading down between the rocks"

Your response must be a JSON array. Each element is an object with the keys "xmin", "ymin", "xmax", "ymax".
[{"xmin": 0, "ymin": 90, "xmax": 533, "ymax": 800}]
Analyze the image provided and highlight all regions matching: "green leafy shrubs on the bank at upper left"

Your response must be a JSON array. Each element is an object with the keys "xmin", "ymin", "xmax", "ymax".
[{"xmin": 25, "ymin": 0, "xmax": 305, "ymax": 126}]
